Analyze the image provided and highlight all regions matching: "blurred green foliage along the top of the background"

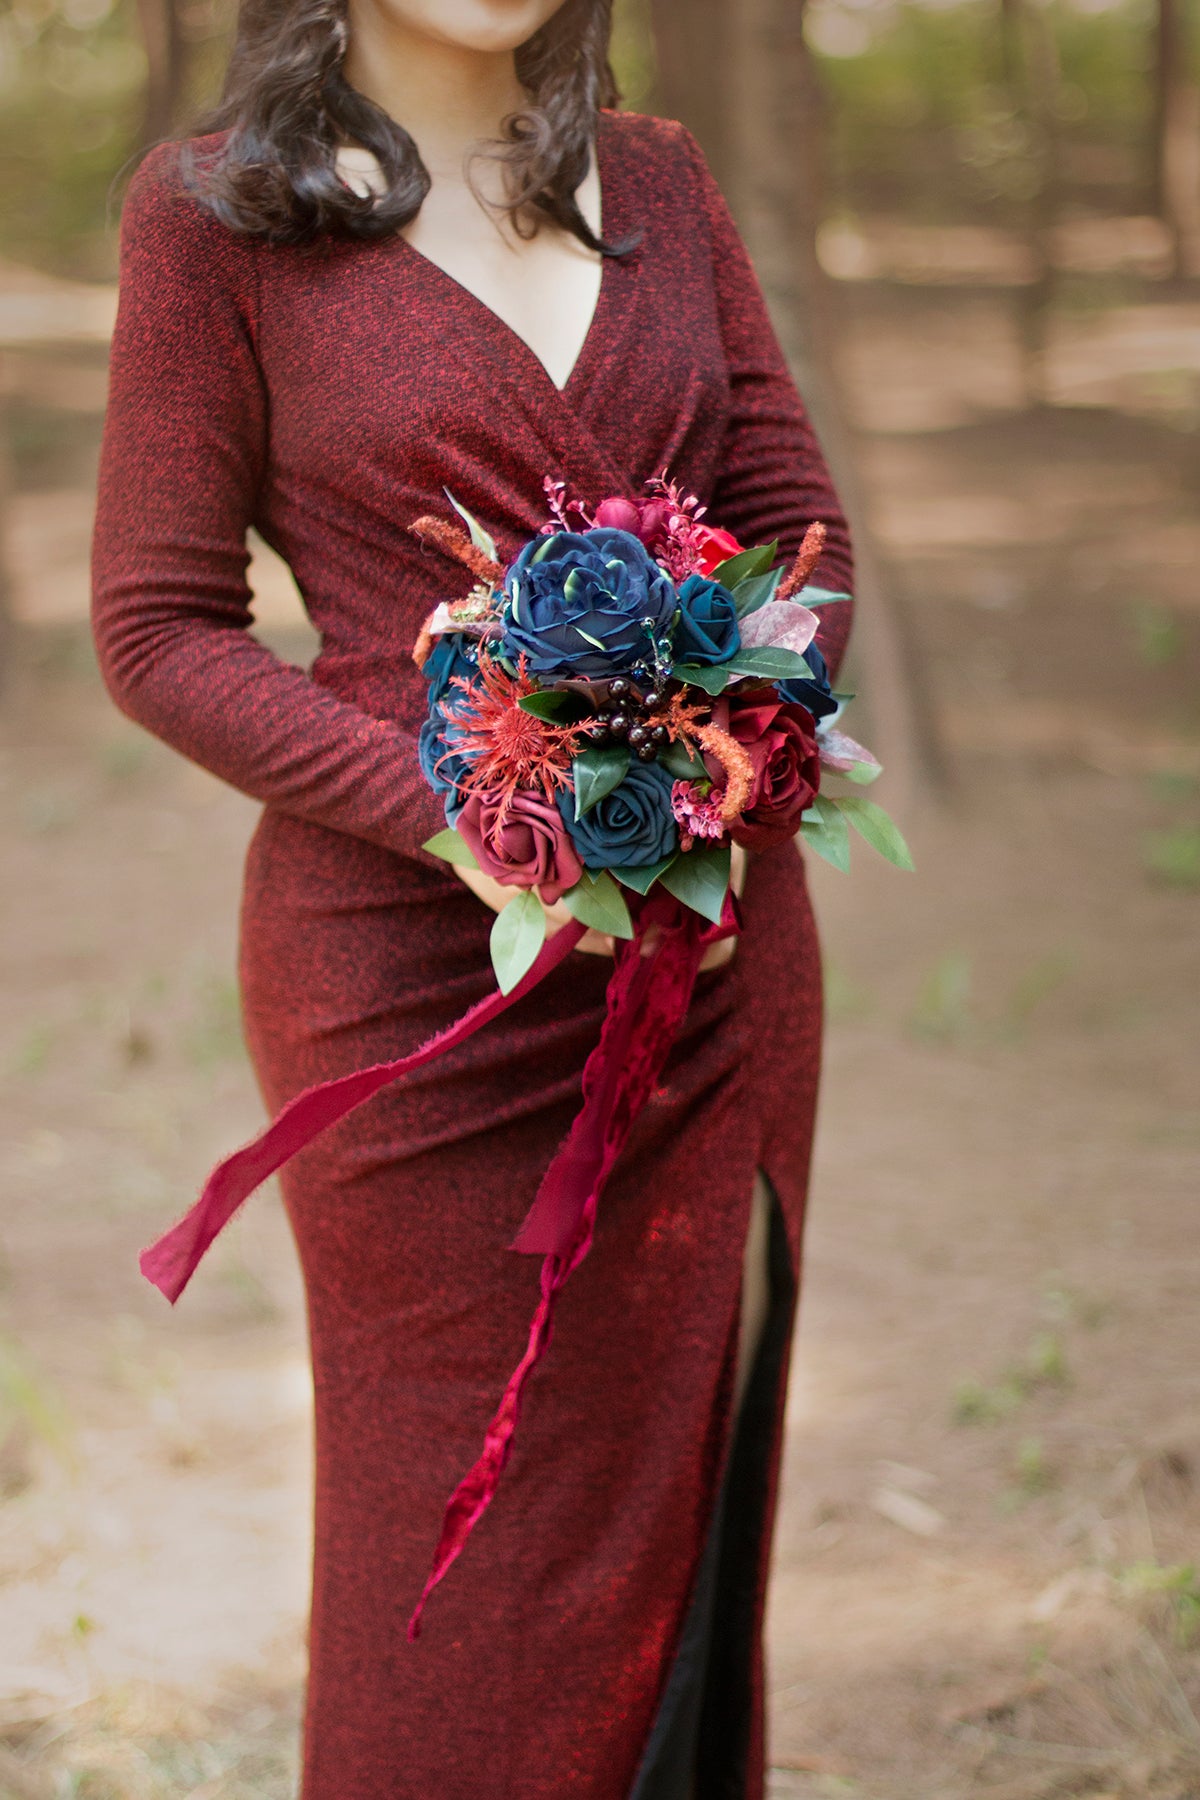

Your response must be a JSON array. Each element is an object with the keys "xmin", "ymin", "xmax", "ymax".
[{"xmin": 0, "ymin": 0, "xmax": 1196, "ymax": 279}]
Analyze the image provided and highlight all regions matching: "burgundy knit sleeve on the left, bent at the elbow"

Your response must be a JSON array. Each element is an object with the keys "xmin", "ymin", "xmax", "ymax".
[{"xmin": 92, "ymin": 146, "xmax": 444, "ymax": 866}]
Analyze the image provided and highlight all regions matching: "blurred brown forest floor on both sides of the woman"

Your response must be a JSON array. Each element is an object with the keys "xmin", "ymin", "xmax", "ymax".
[{"xmin": 0, "ymin": 238, "xmax": 1200, "ymax": 1800}]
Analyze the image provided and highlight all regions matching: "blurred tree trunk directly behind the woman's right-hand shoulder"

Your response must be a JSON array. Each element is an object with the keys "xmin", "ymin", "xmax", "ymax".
[{"xmin": 655, "ymin": 0, "xmax": 941, "ymax": 805}]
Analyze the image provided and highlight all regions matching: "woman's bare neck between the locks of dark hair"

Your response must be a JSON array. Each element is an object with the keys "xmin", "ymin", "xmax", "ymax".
[{"xmin": 344, "ymin": 0, "xmax": 527, "ymax": 180}]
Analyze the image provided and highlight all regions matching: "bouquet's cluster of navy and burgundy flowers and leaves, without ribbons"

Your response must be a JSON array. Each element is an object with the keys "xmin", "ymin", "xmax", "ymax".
[{"xmin": 412, "ymin": 477, "xmax": 910, "ymax": 992}]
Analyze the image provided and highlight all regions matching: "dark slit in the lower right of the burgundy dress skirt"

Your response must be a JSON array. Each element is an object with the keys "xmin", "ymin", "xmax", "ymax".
[{"xmin": 630, "ymin": 1170, "xmax": 797, "ymax": 1800}]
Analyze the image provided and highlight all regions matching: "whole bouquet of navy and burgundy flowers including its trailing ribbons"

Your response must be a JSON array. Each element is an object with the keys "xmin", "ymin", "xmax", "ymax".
[{"xmin": 140, "ymin": 477, "xmax": 912, "ymax": 1638}]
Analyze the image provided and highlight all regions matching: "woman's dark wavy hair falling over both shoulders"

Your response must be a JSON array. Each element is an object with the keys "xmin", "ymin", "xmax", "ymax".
[{"xmin": 180, "ymin": 0, "xmax": 628, "ymax": 256}]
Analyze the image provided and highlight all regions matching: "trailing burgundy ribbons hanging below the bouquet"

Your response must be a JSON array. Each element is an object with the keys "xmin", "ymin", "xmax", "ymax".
[{"xmin": 139, "ymin": 891, "xmax": 741, "ymax": 1640}]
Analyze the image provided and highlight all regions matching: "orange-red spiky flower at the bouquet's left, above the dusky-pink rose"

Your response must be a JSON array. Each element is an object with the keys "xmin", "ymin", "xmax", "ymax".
[{"xmin": 443, "ymin": 644, "xmax": 590, "ymax": 821}]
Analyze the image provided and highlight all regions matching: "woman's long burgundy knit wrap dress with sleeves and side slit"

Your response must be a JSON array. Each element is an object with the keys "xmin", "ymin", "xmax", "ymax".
[{"xmin": 94, "ymin": 113, "xmax": 851, "ymax": 1800}]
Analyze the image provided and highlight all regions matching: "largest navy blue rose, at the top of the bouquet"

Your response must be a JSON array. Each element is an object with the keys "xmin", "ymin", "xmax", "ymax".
[{"xmin": 502, "ymin": 527, "xmax": 675, "ymax": 677}]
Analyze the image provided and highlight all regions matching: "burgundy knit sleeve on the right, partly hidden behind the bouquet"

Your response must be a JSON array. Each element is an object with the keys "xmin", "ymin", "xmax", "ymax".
[{"xmin": 680, "ymin": 126, "xmax": 855, "ymax": 671}]
